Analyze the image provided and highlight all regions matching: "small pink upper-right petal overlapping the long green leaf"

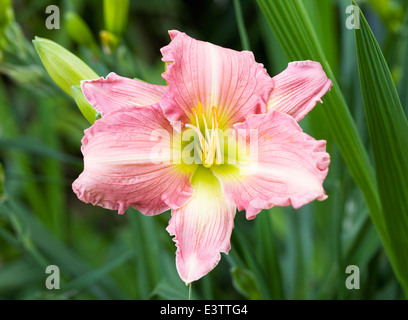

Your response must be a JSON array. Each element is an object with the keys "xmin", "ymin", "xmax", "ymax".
[{"xmin": 268, "ymin": 60, "xmax": 332, "ymax": 122}]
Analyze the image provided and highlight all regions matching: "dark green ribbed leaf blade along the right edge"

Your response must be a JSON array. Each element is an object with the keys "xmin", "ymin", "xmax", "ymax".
[{"xmin": 353, "ymin": 2, "xmax": 408, "ymax": 297}]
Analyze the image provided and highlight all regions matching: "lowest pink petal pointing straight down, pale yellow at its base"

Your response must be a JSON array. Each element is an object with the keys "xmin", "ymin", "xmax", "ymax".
[{"xmin": 167, "ymin": 168, "xmax": 236, "ymax": 284}]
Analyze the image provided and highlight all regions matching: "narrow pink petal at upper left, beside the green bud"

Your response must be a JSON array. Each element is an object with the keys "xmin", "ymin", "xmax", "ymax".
[{"xmin": 81, "ymin": 72, "xmax": 167, "ymax": 115}]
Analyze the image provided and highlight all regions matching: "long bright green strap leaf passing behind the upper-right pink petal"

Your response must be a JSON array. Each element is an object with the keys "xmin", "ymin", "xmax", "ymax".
[{"xmin": 257, "ymin": 0, "xmax": 387, "ymax": 236}]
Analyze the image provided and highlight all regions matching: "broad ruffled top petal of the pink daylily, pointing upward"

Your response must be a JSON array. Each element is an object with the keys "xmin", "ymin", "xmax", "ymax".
[{"xmin": 160, "ymin": 30, "xmax": 273, "ymax": 128}]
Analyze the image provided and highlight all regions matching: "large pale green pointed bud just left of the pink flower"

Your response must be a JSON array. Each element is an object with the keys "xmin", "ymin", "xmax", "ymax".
[{"xmin": 33, "ymin": 37, "xmax": 99, "ymax": 96}]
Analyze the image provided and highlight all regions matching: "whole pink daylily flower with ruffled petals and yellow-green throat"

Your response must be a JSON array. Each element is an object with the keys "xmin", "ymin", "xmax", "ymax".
[{"xmin": 73, "ymin": 31, "xmax": 332, "ymax": 283}]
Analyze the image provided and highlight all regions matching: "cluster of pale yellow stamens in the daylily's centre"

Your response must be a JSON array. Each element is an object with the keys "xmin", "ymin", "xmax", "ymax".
[{"xmin": 185, "ymin": 102, "xmax": 223, "ymax": 168}]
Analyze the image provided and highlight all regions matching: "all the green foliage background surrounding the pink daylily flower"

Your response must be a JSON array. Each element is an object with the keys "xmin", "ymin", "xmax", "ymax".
[{"xmin": 0, "ymin": 0, "xmax": 408, "ymax": 299}]
